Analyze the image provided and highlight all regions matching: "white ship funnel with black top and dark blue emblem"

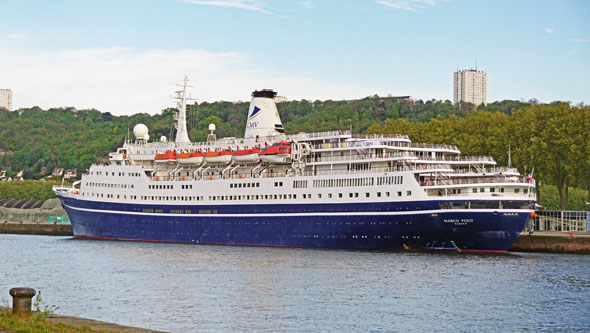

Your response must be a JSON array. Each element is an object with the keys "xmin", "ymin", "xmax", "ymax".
[{"xmin": 244, "ymin": 89, "xmax": 285, "ymax": 139}]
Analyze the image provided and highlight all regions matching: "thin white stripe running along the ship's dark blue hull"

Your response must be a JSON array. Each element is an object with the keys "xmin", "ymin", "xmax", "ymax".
[{"xmin": 64, "ymin": 205, "xmax": 533, "ymax": 217}]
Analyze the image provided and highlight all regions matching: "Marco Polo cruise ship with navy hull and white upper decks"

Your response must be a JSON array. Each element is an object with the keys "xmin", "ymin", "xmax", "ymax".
[{"xmin": 54, "ymin": 78, "xmax": 535, "ymax": 252}]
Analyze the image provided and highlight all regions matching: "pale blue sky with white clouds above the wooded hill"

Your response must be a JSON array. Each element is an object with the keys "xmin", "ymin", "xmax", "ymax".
[{"xmin": 0, "ymin": 0, "xmax": 590, "ymax": 115}]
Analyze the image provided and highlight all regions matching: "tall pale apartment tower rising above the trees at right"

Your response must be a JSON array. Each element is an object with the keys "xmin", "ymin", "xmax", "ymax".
[{"xmin": 453, "ymin": 69, "xmax": 488, "ymax": 106}]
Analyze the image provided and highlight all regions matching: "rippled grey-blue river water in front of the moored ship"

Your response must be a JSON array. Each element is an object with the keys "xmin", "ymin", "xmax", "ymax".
[{"xmin": 0, "ymin": 235, "xmax": 590, "ymax": 332}]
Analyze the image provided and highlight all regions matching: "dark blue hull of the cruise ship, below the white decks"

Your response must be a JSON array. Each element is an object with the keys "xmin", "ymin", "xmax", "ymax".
[{"xmin": 60, "ymin": 197, "xmax": 530, "ymax": 252}]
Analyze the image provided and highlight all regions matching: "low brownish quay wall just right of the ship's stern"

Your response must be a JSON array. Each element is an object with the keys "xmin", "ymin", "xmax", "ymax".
[{"xmin": 508, "ymin": 231, "xmax": 590, "ymax": 254}]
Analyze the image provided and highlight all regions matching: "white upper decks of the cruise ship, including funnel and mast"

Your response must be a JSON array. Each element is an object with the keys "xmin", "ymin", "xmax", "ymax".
[{"xmin": 61, "ymin": 81, "xmax": 535, "ymax": 205}]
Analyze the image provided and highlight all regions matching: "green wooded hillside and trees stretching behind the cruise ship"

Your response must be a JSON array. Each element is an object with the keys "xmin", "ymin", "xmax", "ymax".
[{"xmin": 0, "ymin": 96, "xmax": 590, "ymax": 209}]
